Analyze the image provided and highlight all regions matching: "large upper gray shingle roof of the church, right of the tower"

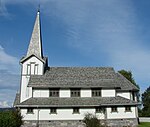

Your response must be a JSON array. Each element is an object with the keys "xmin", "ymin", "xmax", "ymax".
[{"xmin": 28, "ymin": 67, "xmax": 138, "ymax": 90}]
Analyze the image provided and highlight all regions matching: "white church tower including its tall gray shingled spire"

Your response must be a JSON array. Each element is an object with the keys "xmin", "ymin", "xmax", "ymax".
[{"xmin": 20, "ymin": 11, "xmax": 48, "ymax": 102}]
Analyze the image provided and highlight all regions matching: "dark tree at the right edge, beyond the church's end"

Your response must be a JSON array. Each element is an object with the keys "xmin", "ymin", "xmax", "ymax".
[{"xmin": 142, "ymin": 86, "xmax": 150, "ymax": 117}]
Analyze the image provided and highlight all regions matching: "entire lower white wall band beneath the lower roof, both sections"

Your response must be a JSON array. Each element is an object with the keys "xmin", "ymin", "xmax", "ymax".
[{"xmin": 21, "ymin": 107, "xmax": 136, "ymax": 120}]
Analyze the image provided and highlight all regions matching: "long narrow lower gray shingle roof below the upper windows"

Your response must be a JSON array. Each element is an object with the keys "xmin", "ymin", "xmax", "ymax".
[{"xmin": 16, "ymin": 96, "xmax": 137, "ymax": 107}]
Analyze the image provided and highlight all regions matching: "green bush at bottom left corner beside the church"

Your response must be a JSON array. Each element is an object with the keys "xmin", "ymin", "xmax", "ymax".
[{"xmin": 0, "ymin": 110, "xmax": 23, "ymax": 127}]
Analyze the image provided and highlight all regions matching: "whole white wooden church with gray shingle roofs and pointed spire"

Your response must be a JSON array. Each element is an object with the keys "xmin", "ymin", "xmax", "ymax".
[{"xmin": 14, "ymin": 11, "xmax": 139, "ymax": 127}]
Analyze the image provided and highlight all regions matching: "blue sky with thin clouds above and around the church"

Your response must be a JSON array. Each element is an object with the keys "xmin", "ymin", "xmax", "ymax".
[{"xmin": 0, "ymin": 0, "xmax": 150, "ymax": 107}]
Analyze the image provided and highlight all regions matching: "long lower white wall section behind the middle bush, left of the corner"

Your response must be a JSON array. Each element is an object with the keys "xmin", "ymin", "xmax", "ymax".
[{"xmin": 21, "ymin": 108, "xmax": 104, "ymax": 120}]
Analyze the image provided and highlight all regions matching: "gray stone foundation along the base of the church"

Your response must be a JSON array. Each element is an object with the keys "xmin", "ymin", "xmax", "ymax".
[{"xmin": 22, "ymin": 119, "xmax": 138, "ymax": 127}]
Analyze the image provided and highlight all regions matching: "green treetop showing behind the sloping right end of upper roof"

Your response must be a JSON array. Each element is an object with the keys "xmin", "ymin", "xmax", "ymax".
[{"xmin": 118, "ymin": 70, "xmax": 140, "ymax": 88}]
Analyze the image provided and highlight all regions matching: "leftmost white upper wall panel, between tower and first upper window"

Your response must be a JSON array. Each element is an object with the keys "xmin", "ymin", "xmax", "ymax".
[{"xmin": 33, "ymin": 89, "xmax": 49, "ymax": 97}]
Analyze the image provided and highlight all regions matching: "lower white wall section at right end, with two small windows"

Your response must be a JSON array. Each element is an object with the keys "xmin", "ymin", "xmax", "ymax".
[{"xmin": 107, "ymin": 107, "xmax": 136, "ymax": 119}]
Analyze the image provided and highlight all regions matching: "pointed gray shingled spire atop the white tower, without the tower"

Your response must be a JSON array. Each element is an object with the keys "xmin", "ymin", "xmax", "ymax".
[{"xmin": 27, "ymin": 10, "xmax": 43, "ymax": 58}]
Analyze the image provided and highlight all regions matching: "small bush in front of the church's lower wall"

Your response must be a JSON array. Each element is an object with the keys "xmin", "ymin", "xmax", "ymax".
[{"xmin": 83, "ymin": 113, "xmax": 103, "ymax": 127}]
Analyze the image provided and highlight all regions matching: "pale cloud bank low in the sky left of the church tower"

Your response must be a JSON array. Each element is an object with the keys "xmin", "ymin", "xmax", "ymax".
[{"xmin": 0, "ymin": 45, "xmax": 20, "ymax": 107}]
